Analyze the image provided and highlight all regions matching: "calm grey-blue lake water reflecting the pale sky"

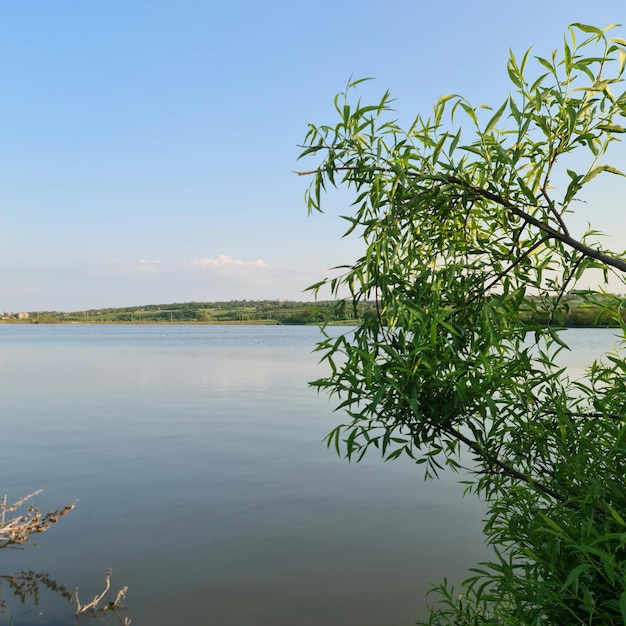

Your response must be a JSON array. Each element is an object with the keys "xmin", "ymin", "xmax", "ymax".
[{"xmin": 0, "ymin": 325, "xmax": 612, "ymax": 626}]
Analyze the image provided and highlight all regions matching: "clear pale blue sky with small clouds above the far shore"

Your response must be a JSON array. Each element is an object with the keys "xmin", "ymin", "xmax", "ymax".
[{"xmin": 0, "ymin": 0, "xmax": 626, "ymax": 311}]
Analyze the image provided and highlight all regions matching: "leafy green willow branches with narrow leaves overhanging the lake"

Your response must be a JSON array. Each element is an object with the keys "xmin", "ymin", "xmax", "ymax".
[{"xmin": 302, "ymin": 24, "xmax": 626, "ymax": 626}]
